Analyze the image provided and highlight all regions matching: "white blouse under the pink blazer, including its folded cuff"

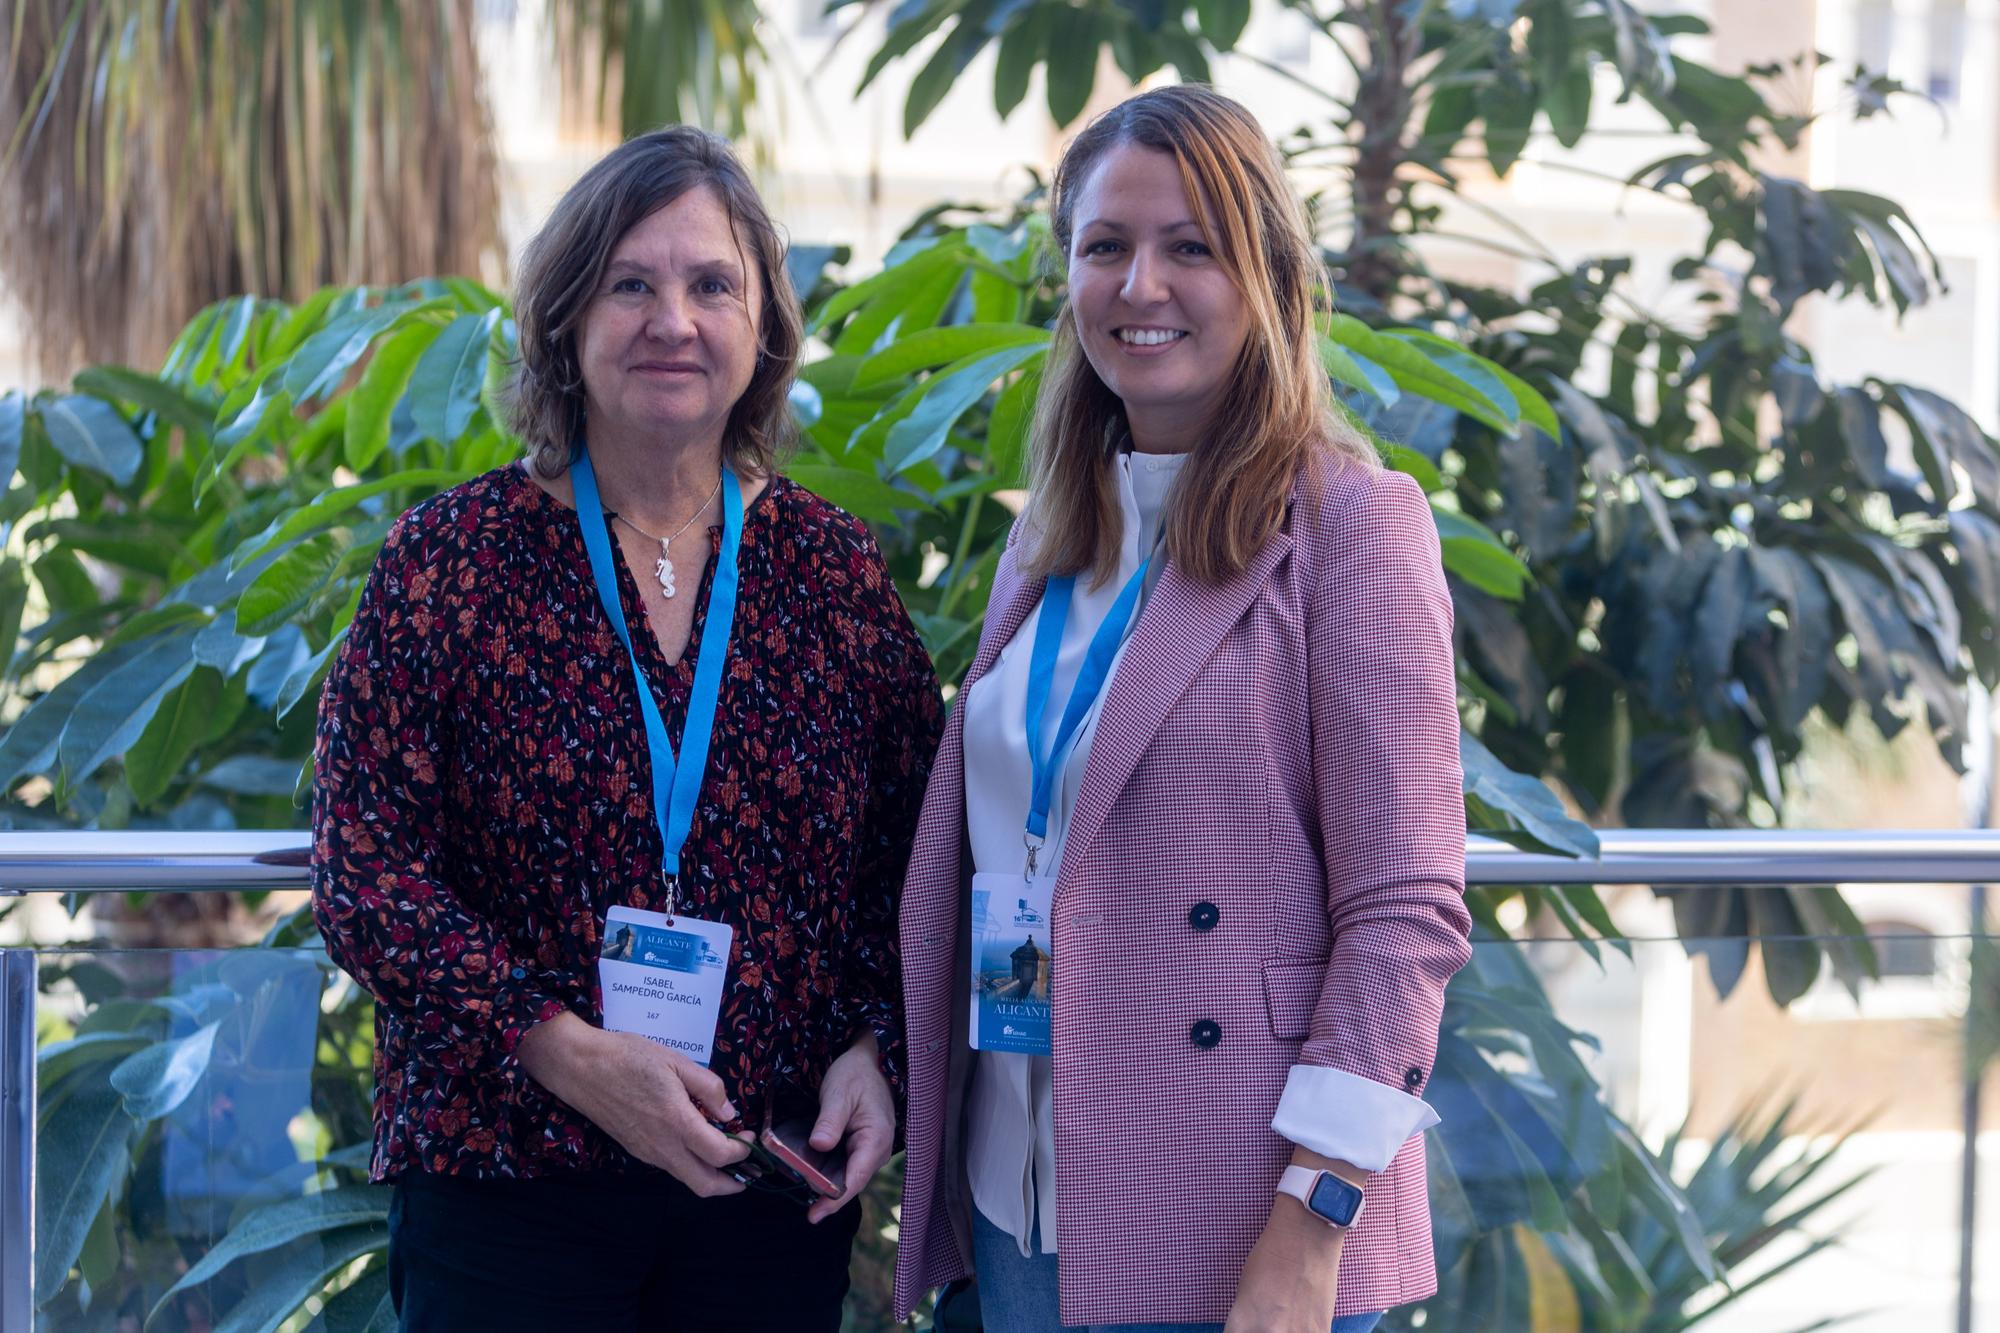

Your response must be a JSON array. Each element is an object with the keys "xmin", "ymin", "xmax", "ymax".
[{"xmin": 960, "ymin": 452, "xmax": 1438, "ymax": 1255}]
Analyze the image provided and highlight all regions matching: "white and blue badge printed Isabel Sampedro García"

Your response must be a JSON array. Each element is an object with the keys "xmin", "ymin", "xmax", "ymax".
[{"xmin": 598, "ymin": 907, "xmax": 732, "ymax": 1065}]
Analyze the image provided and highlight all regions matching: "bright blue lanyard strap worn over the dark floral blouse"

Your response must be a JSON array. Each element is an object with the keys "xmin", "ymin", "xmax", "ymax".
[{"xmin": 570, "ymin": 448, "xmax": 744, "ymax": 904}]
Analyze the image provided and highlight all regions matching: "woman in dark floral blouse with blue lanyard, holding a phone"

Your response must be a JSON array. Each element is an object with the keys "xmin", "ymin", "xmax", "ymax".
[{"xmin": 312, "ymin": 128, "xmax": 942, "ymax": 1331}]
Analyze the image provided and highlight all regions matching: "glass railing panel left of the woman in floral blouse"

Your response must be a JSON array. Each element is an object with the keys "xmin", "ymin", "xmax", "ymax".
[{"xmin": 34, "ymin": 949, "xmax": 388, "ymax": 1331}]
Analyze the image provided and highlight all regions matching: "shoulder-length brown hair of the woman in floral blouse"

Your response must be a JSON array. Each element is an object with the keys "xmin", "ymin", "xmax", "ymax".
[{"xmin": 504, "ymin": 124, "xmax": 804, "ymax": 476}]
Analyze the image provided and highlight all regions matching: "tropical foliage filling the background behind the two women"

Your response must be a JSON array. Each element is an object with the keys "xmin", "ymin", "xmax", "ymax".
[{"xmin": 0, "ymin": 0, "xmax": 2000, "ymax": 1329}]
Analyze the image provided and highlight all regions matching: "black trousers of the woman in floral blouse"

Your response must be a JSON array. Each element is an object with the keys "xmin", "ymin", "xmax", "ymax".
[{"xmin": 388, "ymin": 1173, "xmax": 862, "ymax": 1333}]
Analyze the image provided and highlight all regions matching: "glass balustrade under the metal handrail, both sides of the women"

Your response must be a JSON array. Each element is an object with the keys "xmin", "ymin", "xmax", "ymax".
[{"xmin": 0, "ymin": 887, "xmax": 2000, "ymax": 1333}]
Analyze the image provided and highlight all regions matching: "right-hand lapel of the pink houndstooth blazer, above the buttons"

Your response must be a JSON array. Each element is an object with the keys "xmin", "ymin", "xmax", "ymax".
[{"xmin": 1064, "ymin": 530, "xmax": 1292, "ymax": 891}]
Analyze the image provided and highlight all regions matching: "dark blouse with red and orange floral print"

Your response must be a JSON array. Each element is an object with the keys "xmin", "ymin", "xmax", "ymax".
[{"xmin": 312, "ymin": 464, "xmax": 942, "ymax": 1181}]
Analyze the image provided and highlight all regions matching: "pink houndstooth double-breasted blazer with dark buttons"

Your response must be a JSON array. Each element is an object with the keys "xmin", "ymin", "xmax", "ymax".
[{"xmin": 896, "ymin": 454, "xmax": 1470, "ymax": 1323}]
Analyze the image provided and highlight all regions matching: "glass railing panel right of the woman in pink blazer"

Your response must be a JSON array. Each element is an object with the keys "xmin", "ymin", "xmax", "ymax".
[{"xmin": 1424, "ymin": 917, "xmax": 2000, "ymax": 1333}]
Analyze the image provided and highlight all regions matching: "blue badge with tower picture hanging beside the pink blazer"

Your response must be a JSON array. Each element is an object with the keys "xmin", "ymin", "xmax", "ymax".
[{"xmin": 970, "ymin": 871, "xmax": 1056, "ymax": 1055}]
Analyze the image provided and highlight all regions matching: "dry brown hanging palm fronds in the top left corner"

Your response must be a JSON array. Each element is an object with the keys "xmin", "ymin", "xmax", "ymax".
[{"xmin": 0, "ymin": 0, "xmax": 504, "ymax": 378}]
